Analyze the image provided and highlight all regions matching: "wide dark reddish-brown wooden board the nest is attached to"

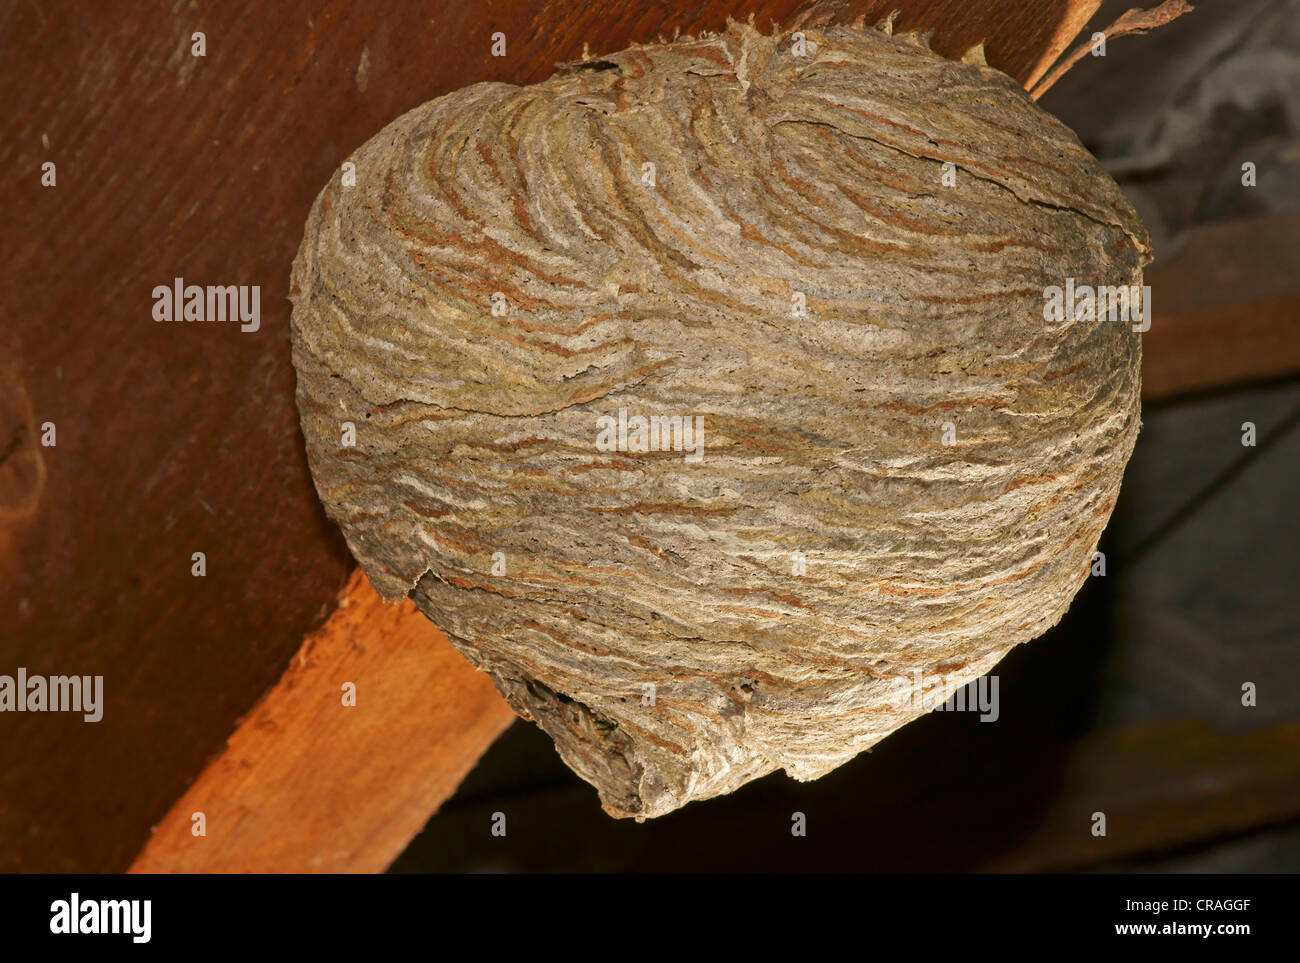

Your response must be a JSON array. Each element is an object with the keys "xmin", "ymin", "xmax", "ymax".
[{"xmin": 0, "ymin": 0, "xmax": 1107, "ymax": 871}]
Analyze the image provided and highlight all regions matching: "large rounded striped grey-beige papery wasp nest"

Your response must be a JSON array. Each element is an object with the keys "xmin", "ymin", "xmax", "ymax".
[{"xmin": 291, "ymin": 15, "xmax": 1149, "ymax": 817}]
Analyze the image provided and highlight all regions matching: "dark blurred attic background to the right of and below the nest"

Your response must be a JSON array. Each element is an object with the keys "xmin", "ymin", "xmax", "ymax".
[{"xmin": 393, "ymin": 0, "xmax": 1300, "ymax": 872}]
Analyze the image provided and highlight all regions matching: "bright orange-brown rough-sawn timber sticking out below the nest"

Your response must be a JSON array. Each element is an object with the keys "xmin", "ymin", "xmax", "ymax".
[{"xmin": 130, "ymin": 569, "xmax": 515, "ymax": 873}]
